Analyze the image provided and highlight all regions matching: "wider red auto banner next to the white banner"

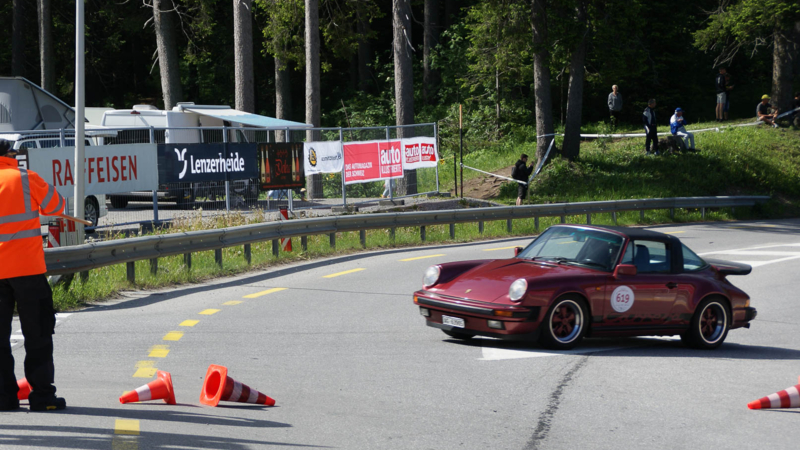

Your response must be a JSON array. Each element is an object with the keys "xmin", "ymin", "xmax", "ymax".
[{"xmin": 344, "ymin": 140, "xmax": 403, "ymax": 184}]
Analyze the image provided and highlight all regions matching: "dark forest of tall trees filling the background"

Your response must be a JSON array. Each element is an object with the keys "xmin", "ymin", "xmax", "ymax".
[{"xmin": 0, "ymin": 0, "xmax": 800, "ymax": 195}]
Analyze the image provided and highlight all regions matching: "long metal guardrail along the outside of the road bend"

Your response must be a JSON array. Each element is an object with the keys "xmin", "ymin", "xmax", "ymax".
[{"xmin": 45, "ymin": 196, "xmax": 770, "ymax": 281}]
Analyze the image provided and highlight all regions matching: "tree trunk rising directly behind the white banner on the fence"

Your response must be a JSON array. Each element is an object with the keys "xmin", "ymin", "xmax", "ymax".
[{"xmin": 305, "ymin": 0, "xmax": 323, "ymax": 198}]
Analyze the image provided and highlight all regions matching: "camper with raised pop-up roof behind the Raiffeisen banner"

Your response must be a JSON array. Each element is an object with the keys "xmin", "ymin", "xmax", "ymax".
[{"xmin": 0, "ymin": 77, "xmax": 113, "ymax": 230}]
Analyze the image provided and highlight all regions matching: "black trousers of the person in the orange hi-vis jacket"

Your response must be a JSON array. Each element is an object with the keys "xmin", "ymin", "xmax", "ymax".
[{"xmin": 0, "ymin": 275, "xmax": 56, "ymax": 406}]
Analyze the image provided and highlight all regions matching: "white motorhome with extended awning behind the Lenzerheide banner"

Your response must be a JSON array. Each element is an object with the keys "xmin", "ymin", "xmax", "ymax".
[{"xmin": 100, "ymin": 102, "xmax": 309, "ymax": 208}]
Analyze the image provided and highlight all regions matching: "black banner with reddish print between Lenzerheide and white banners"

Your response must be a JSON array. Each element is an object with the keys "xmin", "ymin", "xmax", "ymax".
[{"xmin": 258, "ymin": 142, "xmax": 306, "ymax": 190}]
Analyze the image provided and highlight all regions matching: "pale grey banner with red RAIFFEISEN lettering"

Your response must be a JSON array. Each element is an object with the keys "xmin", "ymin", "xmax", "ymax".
[{"xmin": 28, "ymin": 144, "xmax": 158, "ymax": 197}]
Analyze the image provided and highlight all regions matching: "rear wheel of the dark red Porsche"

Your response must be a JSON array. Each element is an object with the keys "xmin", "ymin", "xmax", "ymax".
[{"xmin": 681, "ymin": 298, "xmax": 731, "ymax": 350}]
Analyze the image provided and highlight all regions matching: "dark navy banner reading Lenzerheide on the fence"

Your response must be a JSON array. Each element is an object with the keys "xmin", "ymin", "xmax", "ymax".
[{"xmin": 158, "ymin": 143, "xmax": 258, "ymax": 184}]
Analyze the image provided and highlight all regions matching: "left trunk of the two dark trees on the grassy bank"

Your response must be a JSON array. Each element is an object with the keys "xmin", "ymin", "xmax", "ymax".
[{"xmin": 531, "ymin": 0, "xmax": 553, "ymax": 166}]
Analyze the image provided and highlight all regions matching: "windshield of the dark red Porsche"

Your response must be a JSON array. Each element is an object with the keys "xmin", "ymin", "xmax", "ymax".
[{"xmin": 517, "ymin": 226, "xmax": 625, "ymax": 271}]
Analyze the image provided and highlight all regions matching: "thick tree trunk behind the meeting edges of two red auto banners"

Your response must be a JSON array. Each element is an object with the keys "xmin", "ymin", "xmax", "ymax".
[{"xmin": 392, "ymin": 0, "xmax": 417, "ymax": 195}]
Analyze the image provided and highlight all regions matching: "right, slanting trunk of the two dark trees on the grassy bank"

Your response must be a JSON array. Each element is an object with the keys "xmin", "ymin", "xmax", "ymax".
[{"xmin": 562, "ymin": 0, "xmax": 589, "ymax": 161}]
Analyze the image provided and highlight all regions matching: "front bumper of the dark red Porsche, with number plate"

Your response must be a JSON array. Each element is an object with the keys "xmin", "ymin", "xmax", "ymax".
[{"xmin": 414, "ymin": 292, "xmax": 541, "ymax": 339}]
